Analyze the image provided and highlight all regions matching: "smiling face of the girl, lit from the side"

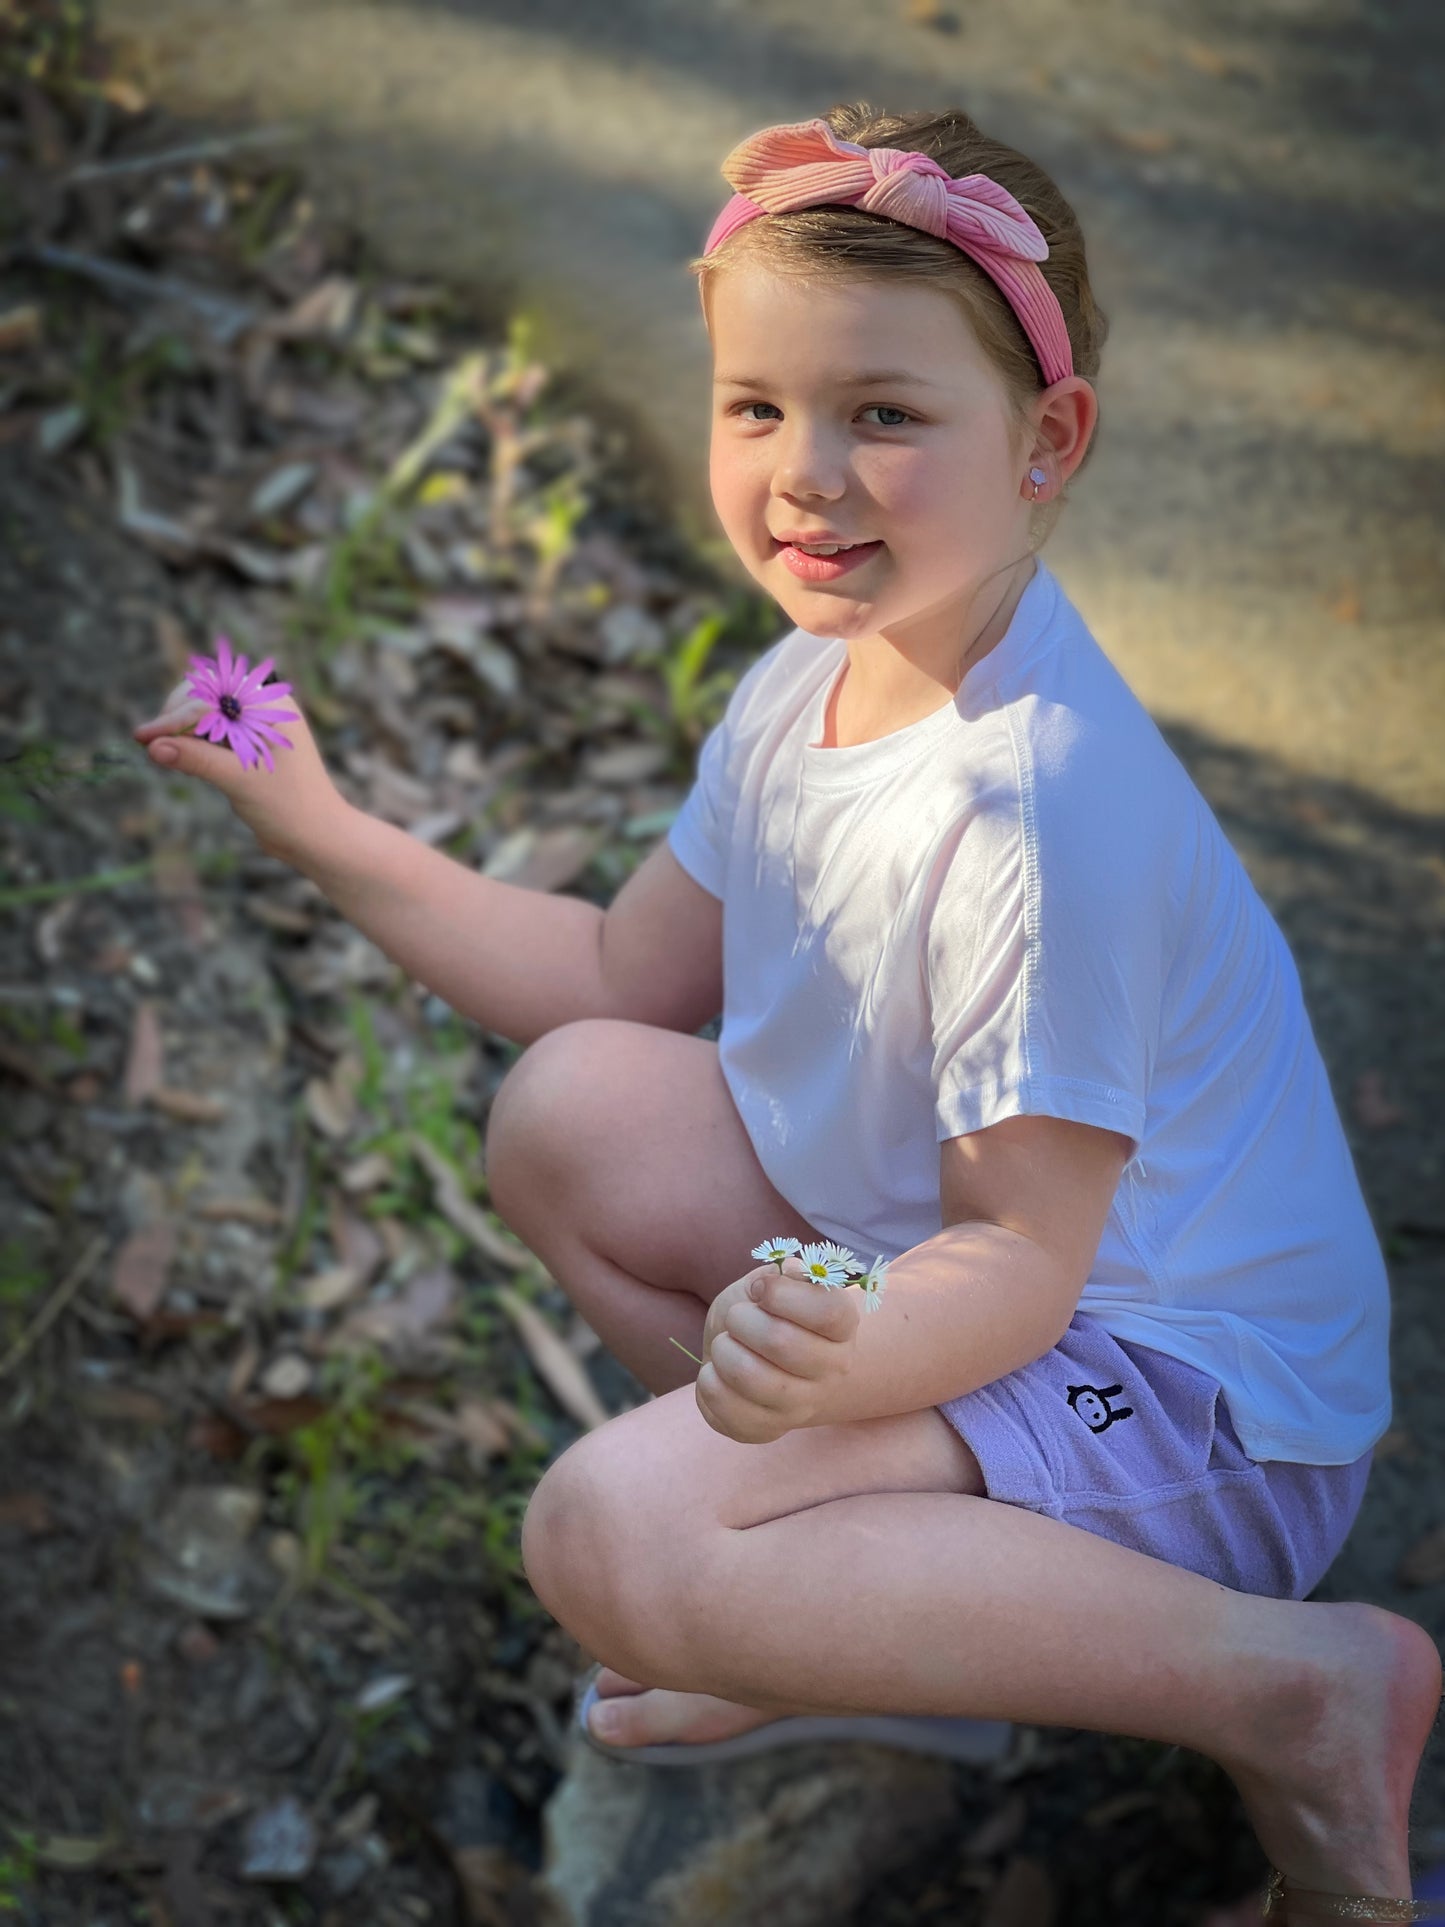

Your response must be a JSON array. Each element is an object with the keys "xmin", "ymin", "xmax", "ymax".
[{"xmin": 711, "ymin": 268, "xmax": 1033, "ymax": 676}]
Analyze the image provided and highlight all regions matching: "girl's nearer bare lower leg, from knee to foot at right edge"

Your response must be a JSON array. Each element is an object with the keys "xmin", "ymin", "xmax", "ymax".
[{"xmin": 524, "ymin": 1389, "xmax": 1441, "ymax": 1894}]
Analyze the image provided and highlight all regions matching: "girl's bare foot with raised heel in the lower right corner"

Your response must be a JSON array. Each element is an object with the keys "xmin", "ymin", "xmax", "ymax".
[{"xmin": 1216, "ymin": 1601, "xmax": 1441, "ymax": 1927}]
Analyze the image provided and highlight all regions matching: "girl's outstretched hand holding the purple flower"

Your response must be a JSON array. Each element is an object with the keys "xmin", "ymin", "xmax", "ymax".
[{"xmin": 131, "ymin": 682, "xmax": 351, "ymax": 863}]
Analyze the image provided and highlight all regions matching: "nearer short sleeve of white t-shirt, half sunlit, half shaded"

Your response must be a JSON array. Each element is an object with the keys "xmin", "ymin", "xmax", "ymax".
[{"xmin": 925, "ymin": 724, "xmax": 1166, "ymax": 1150}]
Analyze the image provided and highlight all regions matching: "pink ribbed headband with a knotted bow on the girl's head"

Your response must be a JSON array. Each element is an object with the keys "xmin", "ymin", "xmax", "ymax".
[{"xmin": 703, "ymin": 119, "xmax": 1073, "ymax": 387}]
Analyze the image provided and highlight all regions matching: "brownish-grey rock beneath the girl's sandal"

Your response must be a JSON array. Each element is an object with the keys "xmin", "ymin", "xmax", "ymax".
[{"xmin": 538, "ymin": 1736, "xmax": 958, "ymax": 1927}]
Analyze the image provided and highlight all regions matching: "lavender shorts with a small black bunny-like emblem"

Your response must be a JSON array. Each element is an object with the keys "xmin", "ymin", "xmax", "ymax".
[{"xmin": 938, "ymin": 1312, "xmax": 1374, "ymax": 1599}]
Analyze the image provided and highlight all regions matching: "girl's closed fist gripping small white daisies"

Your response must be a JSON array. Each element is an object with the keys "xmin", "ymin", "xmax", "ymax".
[{"xmin": 696, "ymin": 1258, "xmax": 863, "ymax": 1445}]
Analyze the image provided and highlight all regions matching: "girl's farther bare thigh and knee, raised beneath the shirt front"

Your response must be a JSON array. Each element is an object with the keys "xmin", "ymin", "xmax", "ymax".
[{"xmin": 486, "ymin": 1017, "xmax": 823, "ymax": 1305}]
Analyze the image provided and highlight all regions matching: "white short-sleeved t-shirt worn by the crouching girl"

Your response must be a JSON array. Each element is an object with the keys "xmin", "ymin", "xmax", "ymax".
[{"xmin": 669, "ymin": 561, "xmax": 1391, "ymax": 1465}]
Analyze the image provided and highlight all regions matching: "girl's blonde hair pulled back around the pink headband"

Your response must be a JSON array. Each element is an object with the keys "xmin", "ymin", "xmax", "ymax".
[{"xmin": 688, "ymin": 100, "xmax": 1108, "ymax": 526}]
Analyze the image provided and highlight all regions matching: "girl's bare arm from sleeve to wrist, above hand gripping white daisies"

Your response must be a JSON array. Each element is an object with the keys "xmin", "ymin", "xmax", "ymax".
[{"xmin": 813, "ymin": 1116, "xmax": 1133, "ymax": 1424}]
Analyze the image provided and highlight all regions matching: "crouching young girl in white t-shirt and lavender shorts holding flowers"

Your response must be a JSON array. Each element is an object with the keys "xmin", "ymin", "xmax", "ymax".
[{"xmin": 137, "ymin": 108, "xmax": 1441, "ymax": 1921}]
